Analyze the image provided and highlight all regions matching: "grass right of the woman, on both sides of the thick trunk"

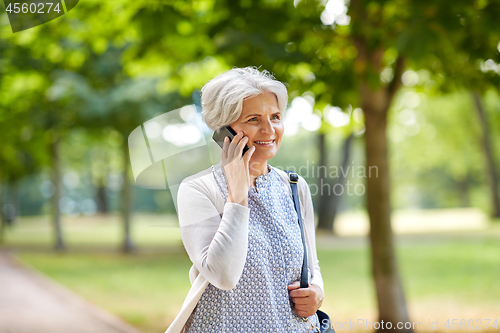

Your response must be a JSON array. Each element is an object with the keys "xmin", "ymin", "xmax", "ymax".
[{"xmin": 318, "ymin": 230, "xmax": 500, "ymax": 332}]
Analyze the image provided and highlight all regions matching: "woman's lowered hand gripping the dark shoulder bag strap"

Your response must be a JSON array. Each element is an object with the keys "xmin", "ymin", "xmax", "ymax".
[{"xmin": 288, "ymin": 281, "xmax": 323, "ymax": 317}]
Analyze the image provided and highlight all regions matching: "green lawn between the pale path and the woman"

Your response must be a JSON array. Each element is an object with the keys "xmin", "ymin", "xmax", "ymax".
[{"xmin": 19, "ymin": 253, "xmax": 191, "ymax": 332}]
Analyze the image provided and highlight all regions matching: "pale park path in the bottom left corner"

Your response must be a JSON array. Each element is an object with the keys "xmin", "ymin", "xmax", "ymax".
[{"xmin": 0, "ymin": 251, "xmax": 140, "ymax": 333}]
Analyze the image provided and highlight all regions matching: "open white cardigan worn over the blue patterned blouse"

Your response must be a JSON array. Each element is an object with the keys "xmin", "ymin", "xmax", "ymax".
[{"xmin": 165, "ymin": 163, "xmax": 324, "ymax": 333}]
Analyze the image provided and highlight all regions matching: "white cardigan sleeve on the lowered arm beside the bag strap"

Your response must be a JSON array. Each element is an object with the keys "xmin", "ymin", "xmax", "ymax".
[{"xmin": 299, "ymin": 177, "xmax": 325, "ymax": 293}]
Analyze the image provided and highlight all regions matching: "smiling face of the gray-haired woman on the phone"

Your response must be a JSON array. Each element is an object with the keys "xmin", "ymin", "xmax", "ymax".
[{"xmin": 231, "ymin": 92, "xmax": 284, "ymax": 163}]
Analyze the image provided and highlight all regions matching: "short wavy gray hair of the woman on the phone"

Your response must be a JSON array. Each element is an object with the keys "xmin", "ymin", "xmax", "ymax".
[{"xmin": 201, "ymin": 67, "xmax": 288, "ymax": 131}]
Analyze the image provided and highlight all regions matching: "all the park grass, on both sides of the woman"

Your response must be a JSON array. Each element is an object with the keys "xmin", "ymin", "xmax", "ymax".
[{"xmin": 6, "ymin": 211, "xmax": 500, "ymax": 333}]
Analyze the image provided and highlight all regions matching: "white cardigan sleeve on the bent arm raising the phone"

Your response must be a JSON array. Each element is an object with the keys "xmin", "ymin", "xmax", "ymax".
[{"xmin": 177, "ymin": 181, "xmax": 250, "ymax": 290}]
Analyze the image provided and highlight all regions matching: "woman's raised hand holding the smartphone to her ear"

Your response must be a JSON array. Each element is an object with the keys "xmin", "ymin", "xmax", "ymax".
[{"xmin": 222, "ymin": 132, "xmax": 255, "ymax": 206}]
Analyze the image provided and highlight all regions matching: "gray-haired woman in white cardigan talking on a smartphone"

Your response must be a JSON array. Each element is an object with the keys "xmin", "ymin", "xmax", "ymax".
[{"xmin": 167, "ymin": 67, "xmax": 323, "ymax": 333}]
